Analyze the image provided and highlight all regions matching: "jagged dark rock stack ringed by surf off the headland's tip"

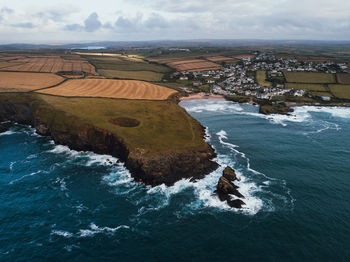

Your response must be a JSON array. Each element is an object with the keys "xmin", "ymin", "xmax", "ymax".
[{"xmin": 216, "ymin": 166, "xmax": 245, "ymax": 208}]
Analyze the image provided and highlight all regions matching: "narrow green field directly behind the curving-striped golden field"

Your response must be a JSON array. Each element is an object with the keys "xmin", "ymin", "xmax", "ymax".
[{"xmin": 98, "ymin": 69, "xmax": 163, "ymax": 82}]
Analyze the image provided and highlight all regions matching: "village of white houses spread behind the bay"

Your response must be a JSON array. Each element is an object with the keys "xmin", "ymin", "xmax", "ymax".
[{"xmin": 173, "ymin": 52, "xmax": 350, "ymax": 100}]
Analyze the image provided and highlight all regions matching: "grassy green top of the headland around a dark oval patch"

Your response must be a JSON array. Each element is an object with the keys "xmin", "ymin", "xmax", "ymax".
[{"xmin": 39, "ymin": 95, "xmax": 205, "ymax": 153}]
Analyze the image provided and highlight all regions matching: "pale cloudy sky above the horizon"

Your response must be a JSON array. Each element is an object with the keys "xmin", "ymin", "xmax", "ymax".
[{"xmin": 0, "ymin": 0, "xmax": 350, "ymax": 44}]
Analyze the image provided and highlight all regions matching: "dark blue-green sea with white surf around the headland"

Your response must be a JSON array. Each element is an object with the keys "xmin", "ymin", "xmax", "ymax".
[{"xmin": 0, "ymin": 99, "xmax": 350, "ymax": 262}]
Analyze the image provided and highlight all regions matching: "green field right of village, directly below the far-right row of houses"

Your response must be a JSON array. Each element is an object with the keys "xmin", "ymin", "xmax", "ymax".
[{"xmin": 284, "ymin": 72, "xmax": 336, "ymax": 84}]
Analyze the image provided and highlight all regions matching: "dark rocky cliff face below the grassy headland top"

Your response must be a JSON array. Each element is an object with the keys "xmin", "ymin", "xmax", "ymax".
[{"xmin": 0, "ymin": 95, "xmax": 218, "ymax": 186}]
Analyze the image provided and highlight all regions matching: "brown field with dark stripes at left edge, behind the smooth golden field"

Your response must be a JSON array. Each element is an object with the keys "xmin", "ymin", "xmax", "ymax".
[{"xmin": 0, "ymin": 55, "xmax": 95, "ymax": 73}]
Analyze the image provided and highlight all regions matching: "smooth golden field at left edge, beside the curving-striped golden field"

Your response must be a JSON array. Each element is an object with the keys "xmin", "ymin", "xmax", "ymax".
[{"xmin": 0, "ymin": 72, "xmax": 64, "ymax": 92}]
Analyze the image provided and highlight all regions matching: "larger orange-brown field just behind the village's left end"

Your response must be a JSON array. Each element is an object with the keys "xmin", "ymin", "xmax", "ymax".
[{"xmin": 167, "ymin": 59, "xmax": 222, "ymax": 72}]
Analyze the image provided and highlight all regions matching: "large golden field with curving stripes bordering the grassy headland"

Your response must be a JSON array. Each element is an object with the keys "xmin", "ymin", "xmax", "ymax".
[{"xmin": 38, "ymin": 79, "xmax": 176, "ymax": 100}]
